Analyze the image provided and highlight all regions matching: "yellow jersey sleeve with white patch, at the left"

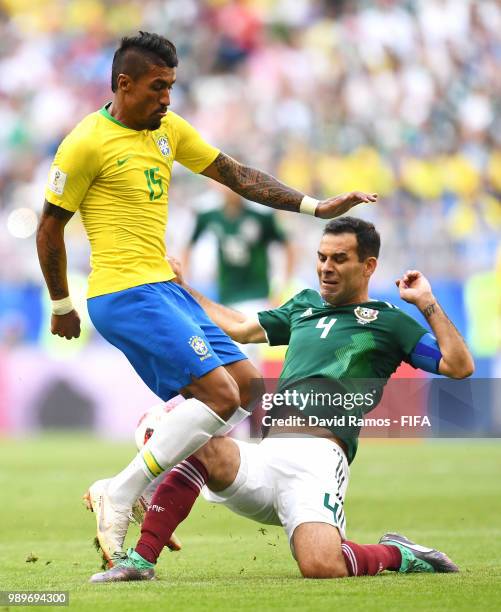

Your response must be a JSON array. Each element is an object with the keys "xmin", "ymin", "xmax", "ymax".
[{"xmin": 45, "ymin": 128, "xmax": 101, "ymax": 212}]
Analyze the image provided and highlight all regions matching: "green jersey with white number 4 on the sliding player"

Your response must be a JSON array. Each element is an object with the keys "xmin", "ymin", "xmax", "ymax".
[{"xmin": 258, "ymin": 289, "xmax": 428, "ymax": 463}]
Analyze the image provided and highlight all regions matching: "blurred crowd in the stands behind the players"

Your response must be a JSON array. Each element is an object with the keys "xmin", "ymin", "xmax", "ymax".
[{"xmin": 0, "ymin": 0, "xmax": 501, "ymax": 432}]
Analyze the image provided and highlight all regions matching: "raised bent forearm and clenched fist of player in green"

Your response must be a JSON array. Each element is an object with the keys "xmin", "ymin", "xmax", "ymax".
[{"xmin": 396, "ymin": 270, "xmax": 475, "ymax": 378}]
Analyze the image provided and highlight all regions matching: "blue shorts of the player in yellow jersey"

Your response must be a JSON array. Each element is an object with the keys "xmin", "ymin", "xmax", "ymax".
[{"xmin": 87, "ymin": 281, "xmax": 247, "ymax": 401}]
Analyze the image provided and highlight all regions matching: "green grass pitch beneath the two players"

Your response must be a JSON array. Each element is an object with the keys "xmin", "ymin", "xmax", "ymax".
[{"xmin": 0, "ymin": 435, "xmax": 501, "ymax": 611}]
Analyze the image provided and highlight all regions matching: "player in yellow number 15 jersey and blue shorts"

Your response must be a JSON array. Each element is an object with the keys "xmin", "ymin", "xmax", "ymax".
[{"xmin": 37, "ymin": 32, "xmax": 376, "ymax": 558}]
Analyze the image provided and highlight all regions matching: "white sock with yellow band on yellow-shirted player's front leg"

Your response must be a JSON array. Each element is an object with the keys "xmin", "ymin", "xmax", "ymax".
[{"xmin": 108, "ymin": 398, "xmax": 226, "ymax": 506}]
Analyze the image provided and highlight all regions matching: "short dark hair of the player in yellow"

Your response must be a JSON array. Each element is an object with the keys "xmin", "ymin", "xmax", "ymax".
[{"xmin": 111, "ymin": 32, "xmax": 178, "ymax": 93}]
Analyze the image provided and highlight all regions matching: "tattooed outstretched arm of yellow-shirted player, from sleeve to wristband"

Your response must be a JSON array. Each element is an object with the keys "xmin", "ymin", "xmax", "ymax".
[{"xmin": 211, "ymin": 153, "xmax": 303, "ymax": 212}]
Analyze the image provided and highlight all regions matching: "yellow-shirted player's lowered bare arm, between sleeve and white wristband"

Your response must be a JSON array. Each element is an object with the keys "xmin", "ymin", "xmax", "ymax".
[{"xmin": 36, "ymin": 200, "xmax": 73, "ymax": 300}]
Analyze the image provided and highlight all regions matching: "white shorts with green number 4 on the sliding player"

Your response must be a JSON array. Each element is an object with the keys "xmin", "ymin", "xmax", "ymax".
[{"xmin": 203, "ymin": 436, "xmax": 349, "ymax": 541}]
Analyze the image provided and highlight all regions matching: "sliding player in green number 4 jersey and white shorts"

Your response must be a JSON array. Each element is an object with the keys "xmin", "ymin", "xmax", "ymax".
[{"xmin": 91, "ymin": 217, "xmax": 474, "ymax": 582}]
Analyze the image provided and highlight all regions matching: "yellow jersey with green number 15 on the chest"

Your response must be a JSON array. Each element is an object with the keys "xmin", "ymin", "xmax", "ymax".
[{"xmin": 45, "ymin": 107, "xmax": 219, "ymax": 297}]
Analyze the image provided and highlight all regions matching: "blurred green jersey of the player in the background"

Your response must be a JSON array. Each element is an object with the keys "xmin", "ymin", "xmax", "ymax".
[{"xmin": 191, "ymin": 207, "xmax": 285, "ymax": 304}]
